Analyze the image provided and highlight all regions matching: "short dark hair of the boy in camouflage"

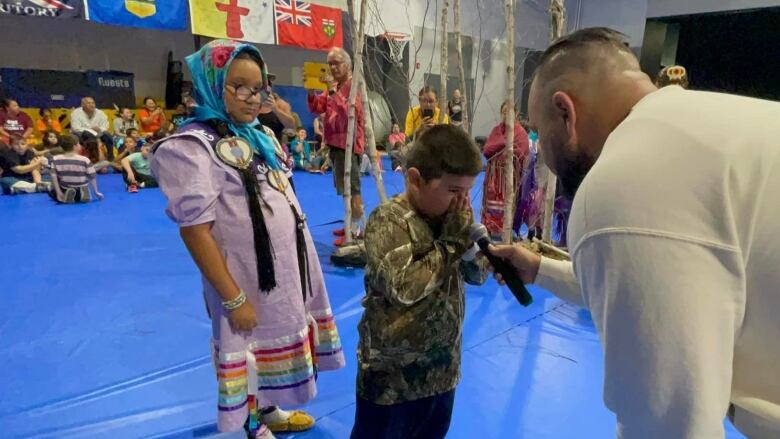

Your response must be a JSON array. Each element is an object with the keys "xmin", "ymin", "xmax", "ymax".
[{"xmin": 406, "ymin": 125, "xmax": 482, "ymax": 181}]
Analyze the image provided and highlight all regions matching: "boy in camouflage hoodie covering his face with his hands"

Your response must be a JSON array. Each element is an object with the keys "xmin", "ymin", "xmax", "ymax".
[{"xmin": 351, "ymin": 125, "xmax": 487, "ymax": 439}]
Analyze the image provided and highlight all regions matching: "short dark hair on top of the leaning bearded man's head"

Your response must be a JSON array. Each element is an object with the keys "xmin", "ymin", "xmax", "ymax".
[{"xmin": 534, "ymin": 27, "xmax": 636, "ymax": 87}]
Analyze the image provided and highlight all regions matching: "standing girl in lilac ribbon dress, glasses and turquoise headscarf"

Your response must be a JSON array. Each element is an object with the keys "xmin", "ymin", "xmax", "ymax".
[{"xmin": 151, "ymin": 40, "xmax": 344, "ymax": 438}]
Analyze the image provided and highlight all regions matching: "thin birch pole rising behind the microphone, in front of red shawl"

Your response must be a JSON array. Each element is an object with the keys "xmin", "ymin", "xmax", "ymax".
[{"xmin": 503, "ymin": 0, "xmax": 516, "ymax": 244}]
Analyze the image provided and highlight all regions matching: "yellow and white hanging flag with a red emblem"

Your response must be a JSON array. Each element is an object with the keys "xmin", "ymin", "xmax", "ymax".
[{"xmin": 190, "ymin": 0, "xmax": 275, "ymax": 44}]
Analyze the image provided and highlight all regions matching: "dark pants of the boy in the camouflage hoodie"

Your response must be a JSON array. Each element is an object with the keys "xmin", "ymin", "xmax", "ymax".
[{"xmin": 350, "ymin": 390, "xmax": 455, "ymax": 439}]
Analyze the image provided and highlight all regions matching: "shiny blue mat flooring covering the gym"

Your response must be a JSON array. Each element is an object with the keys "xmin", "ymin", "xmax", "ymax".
[{"xmin": 0, "ymin": 163, "xmax": 743, "ymax": 439}]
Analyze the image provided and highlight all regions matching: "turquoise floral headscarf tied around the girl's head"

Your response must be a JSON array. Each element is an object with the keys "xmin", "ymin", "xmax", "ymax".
[{"xmin": 185, "ymin": 40, "xmax": 279, "ymax": 169}]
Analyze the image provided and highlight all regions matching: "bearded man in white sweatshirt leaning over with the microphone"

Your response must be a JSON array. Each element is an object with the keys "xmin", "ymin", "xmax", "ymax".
[{"xmin": 488, "ymin": 28, "xmax": 780, "ymax": 439}]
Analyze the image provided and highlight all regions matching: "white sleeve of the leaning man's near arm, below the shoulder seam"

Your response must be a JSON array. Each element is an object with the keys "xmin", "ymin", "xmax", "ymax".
[{"xmin": 573, "ymin": 232, "xmax": 745, "ymax": 439}]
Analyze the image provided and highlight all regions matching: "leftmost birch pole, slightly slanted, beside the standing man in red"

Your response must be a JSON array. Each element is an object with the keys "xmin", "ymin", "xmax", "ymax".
[{"xmin": 343, "ymin": 0, "xmax": 368, "ymax": 243}]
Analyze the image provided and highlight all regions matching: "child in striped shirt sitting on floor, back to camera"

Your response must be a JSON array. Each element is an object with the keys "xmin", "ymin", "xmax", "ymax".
[{"xmin": 49, "ymin": 135, "xmax": 103, "ymax": 204}]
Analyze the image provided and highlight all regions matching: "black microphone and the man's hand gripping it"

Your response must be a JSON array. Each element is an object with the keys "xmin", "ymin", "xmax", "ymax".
[{"xmin": 469, "ymin": 223, "xmax": 539, "ymax": 306}]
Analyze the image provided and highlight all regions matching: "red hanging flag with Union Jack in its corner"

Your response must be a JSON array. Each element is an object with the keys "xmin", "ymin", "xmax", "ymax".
[{"xmin": 274, "ymin": 0, "xmax": 344, "ymax": 51}]
